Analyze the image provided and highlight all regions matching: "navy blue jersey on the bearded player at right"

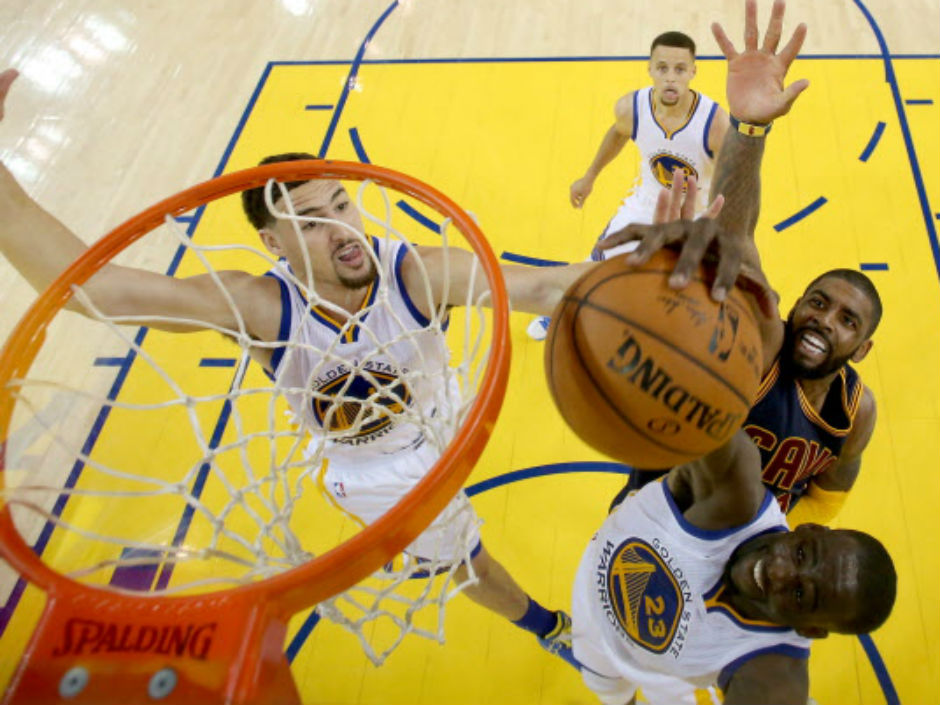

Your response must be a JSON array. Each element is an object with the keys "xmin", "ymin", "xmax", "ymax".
[{"xmin": 744, "ymin": 358, "xmax": 862, "ymax": 512}]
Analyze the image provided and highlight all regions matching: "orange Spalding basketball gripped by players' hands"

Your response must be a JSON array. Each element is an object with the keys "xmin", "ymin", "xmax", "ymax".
[{"xmin": 545, "ymin": 251, "xmax": 762, "ymax": 469}]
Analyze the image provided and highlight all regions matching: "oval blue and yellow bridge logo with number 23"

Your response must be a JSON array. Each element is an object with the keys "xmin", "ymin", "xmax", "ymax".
[{"xmin": 607, "ymin": 538, "xmax": 684, "ymax": 654}]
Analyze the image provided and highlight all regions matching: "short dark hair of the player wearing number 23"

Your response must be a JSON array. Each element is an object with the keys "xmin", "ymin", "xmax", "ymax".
[{"xmin": 838, "ymin": 529, "xmax": 898, "ymax": 634}]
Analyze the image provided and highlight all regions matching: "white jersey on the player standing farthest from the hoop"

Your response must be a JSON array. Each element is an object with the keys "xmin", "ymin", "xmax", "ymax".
[{"xmin": 631, "ymin": 87, "xmax": 718, "ymax": 213}]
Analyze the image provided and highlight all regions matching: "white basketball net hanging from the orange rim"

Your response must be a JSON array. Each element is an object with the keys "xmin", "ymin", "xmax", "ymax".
[{"xmin": 0, "ymin": 175, "xmax": 500, "ymax": 664}]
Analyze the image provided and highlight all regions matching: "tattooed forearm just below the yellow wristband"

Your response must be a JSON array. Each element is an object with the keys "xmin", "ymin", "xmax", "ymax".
[{"xmin": 709, "ymin": 129, "xmax": 764, "ymax": 238}]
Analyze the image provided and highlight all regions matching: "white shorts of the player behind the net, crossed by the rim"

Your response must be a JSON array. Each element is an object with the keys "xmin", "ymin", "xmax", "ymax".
[{"xmin": 318, "ymin": 442, "xmax": 481, "ymax": 562}]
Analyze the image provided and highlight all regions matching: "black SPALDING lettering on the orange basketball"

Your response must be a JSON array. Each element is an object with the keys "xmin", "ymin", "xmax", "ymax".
[{"xmin": 607, "ymin": 331, "xmax": 741, "ymax": 440}]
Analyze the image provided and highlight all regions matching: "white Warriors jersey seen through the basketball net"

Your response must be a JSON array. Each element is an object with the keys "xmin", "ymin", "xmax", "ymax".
[{"xmin": 267, "ymin": 238, "xmax": 454, "ymax": 462}]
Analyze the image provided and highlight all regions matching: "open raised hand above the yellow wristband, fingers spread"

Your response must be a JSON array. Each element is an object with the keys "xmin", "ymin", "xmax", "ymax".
[{"xmin": 712, "ymin": 0, "xmax": 809, "ymax": 124}]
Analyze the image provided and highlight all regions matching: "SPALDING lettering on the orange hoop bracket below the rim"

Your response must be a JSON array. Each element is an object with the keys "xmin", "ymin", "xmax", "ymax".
[{"xmin": 52, "ymin": 618, "xmax": 217, "ymax": 661}]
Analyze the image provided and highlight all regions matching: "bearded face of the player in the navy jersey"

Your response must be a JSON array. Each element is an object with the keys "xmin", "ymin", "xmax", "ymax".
[{"xmin": 784, "ymin": 277, "xmax": 873, "ymax": 379}]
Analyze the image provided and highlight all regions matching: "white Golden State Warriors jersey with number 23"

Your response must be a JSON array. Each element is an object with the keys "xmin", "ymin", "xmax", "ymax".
[{"xmin": 579, "ymin": 481, "xmax": 809, "ymax": 688}]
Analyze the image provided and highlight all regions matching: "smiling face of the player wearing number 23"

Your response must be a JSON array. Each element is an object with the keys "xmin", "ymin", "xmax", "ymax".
[{"xmin": 726, "ymin": 524, "xmax": 860, "ymax": 637}]
